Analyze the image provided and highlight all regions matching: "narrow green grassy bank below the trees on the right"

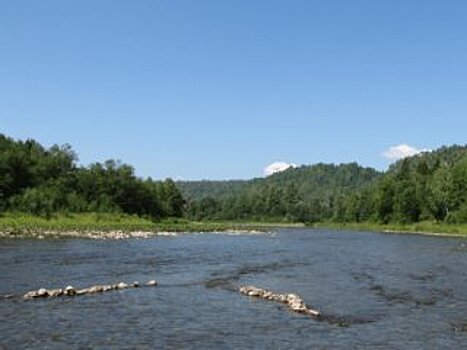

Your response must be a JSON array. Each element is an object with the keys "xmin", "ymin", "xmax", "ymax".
[{"xmin": 310, "ymin": 221, "xmax": 467, "ymax": 237}]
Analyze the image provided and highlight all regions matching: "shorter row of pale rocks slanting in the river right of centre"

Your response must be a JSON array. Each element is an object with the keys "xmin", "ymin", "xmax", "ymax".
[{"xmin": 239, "ymin": 286, "xmax": 320, "ymax": 317}]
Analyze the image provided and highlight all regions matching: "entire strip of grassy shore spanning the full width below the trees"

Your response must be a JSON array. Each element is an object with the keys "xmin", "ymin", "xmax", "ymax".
[{"xmin": 0, "ymin": 213, "xmax": 467, "ymax": 238}]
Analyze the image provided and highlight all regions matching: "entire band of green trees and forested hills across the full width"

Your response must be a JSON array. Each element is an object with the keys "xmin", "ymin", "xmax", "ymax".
[{"xmin": 0, "ymin": 134, "xmax": 467, "ymax": 224}]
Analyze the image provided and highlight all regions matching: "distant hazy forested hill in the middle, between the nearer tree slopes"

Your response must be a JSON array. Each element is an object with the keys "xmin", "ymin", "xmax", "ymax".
[{"xmin": 181, "ymin": 163, "xmax": 381, "ymax": 221}]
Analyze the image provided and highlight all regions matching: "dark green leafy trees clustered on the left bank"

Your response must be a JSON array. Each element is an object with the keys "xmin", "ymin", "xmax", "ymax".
[{"xmin": 0, "ymin": 134, "xmax": 185, "ymax": 219}]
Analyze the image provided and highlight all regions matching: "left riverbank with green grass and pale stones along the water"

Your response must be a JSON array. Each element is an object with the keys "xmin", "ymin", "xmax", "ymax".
[{"xmin": 0, "ymin": 213, "xmax": 304, "ymax": 239}]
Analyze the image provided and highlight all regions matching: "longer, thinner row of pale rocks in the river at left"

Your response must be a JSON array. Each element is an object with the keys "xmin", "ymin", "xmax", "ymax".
[{"xmin": 23, "ymin": 280, "xmax": 157, "ymax": 300}]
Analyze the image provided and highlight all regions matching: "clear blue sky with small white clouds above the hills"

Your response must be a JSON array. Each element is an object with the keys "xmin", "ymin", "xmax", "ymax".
[{"xmin": 0, "ymin": 0, "xmax": 467, "ymax": 180}]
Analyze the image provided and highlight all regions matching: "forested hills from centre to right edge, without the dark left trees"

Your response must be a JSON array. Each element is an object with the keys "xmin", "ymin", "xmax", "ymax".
[{"xmin": 185, "ymin": 146, "xmax": 467, "ymax": 223}]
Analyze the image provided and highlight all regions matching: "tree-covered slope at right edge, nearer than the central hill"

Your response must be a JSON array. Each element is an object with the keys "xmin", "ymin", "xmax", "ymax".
[{"xmin": 356, "ymin": 145, "xmax": 467, "ymax": 223}]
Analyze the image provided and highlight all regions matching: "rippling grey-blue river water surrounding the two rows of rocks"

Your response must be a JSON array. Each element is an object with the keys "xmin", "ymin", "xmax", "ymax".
[{"xmin": 0, "ymin": 229, "xmax": 467, "ymax": 349}]
